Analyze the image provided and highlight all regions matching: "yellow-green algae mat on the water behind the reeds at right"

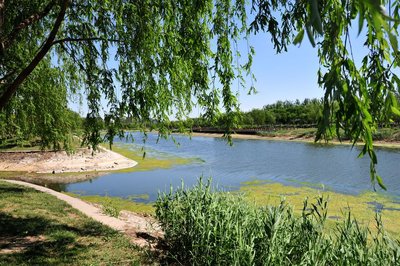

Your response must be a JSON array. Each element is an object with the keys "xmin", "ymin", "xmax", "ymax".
[{"xmin": 240, "ymin": 181, "xmax": 400, "ymax": 237}]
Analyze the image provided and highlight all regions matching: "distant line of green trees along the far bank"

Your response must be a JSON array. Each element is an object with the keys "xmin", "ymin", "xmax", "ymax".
[{"xmin": 0, "ymin": 96, "xmax": 400, "ymax": 149}]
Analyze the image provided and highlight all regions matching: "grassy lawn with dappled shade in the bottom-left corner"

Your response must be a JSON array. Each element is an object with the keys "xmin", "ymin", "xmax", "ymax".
[{"xmin": 0, "ymin": 181, "xmax": 155, "ymax": 265}]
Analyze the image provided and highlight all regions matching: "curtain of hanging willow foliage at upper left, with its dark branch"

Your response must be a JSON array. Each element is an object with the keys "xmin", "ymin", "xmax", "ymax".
[{"xmin": 0, "ymin": 0, "xmax": 252, "ymax": 150}]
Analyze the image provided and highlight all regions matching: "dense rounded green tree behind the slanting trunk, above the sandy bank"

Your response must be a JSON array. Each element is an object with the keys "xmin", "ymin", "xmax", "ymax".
[{"xmin": 0, "ymin": 58, "xmax": 82, "ymax": 150}]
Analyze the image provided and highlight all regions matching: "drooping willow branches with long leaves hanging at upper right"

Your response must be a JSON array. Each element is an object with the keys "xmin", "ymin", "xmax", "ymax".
[{"xmin": 251, "ymin": 0, "xmax": 400, "ymax": 188}]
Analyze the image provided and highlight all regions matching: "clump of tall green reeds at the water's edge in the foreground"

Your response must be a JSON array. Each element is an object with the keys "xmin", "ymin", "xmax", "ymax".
[{"xmin": 156, "ymin": 179, "xmax": 400, "ymax": 265}]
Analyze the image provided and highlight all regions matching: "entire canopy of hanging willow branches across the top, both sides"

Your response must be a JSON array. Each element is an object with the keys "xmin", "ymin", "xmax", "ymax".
[{"xmin": 0, "ymin": 0, "xmax": 400, "ymax": 186}]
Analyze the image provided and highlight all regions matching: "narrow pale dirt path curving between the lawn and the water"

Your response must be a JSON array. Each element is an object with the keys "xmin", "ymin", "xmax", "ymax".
[{"xmin": 2, "ymin": 179, "xmax": 162, "ymax": 247}]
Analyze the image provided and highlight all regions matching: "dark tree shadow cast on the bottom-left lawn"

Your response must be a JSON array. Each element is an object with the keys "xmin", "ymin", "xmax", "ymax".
[{"xmin": 0, "ymin": 211, "xmax": 115, "ymax": 265}]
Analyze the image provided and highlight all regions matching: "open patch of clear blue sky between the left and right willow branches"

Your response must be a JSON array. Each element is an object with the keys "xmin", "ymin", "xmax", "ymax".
[{"xmin": 239, "ymin": 33, "xmax": 323, "ymax": 111}]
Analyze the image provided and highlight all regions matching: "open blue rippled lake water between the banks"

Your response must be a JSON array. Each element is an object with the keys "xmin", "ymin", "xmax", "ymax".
[{"xmin": 62, "ymin": 133, "xmax": 400, "ymax": 201}]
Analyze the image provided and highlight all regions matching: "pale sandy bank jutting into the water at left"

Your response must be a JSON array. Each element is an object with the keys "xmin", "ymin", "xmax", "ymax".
[{"xmin": 0, "ymin": 148, "xmax": 137, "ymax": 174}]
